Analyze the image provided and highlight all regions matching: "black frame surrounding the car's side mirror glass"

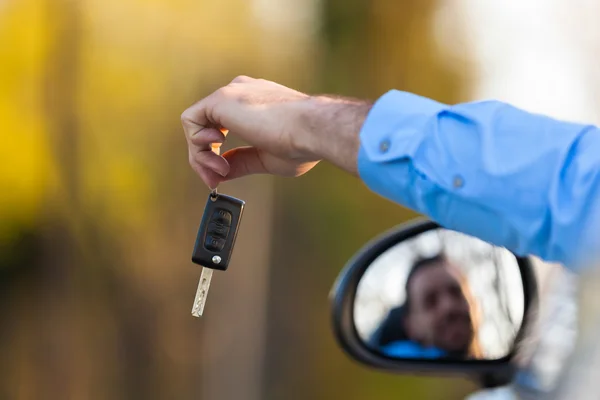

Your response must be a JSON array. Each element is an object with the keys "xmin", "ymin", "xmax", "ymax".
[{"xmin": 330, "ymin": 219, "xmax": 538, "ymax": 387}]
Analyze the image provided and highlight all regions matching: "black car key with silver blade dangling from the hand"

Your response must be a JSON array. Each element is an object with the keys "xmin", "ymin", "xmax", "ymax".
[{"xmin": 192, "ymin": 190, "xmax": 245, "ymax": 317}]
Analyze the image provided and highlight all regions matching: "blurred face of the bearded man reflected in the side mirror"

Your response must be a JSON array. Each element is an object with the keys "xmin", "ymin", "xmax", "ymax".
[{"xmin": 404, "ymin": 261, "xmax": 474, "ymax": 353}]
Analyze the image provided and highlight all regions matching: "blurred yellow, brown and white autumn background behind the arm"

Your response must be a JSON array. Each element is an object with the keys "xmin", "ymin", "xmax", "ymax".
[{"xmin": 0, "ymin": 0, "xmax": 600, "ymax": 400}]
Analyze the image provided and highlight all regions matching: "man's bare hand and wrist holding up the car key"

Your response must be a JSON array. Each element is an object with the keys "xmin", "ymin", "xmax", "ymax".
[{"xmin": 181, "ymin": 76, "xmax": 370, "ymax": 188}]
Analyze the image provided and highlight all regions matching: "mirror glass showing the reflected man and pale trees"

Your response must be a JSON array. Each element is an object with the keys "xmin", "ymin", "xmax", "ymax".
[{"xmin": 354, "ymin": 229, "xmax": 524, "ymax": 360}]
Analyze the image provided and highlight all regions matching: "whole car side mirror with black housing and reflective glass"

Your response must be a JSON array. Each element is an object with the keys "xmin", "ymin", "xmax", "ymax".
[{"xmin": 331, "ymin": 220, "xmax": 537, "ymax": 387}]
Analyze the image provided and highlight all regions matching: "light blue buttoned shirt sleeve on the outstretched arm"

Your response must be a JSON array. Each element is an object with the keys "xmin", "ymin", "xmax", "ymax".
[{"xmin": 358, "ymin": 90, "xmax": 600, "ymax": 269}]
